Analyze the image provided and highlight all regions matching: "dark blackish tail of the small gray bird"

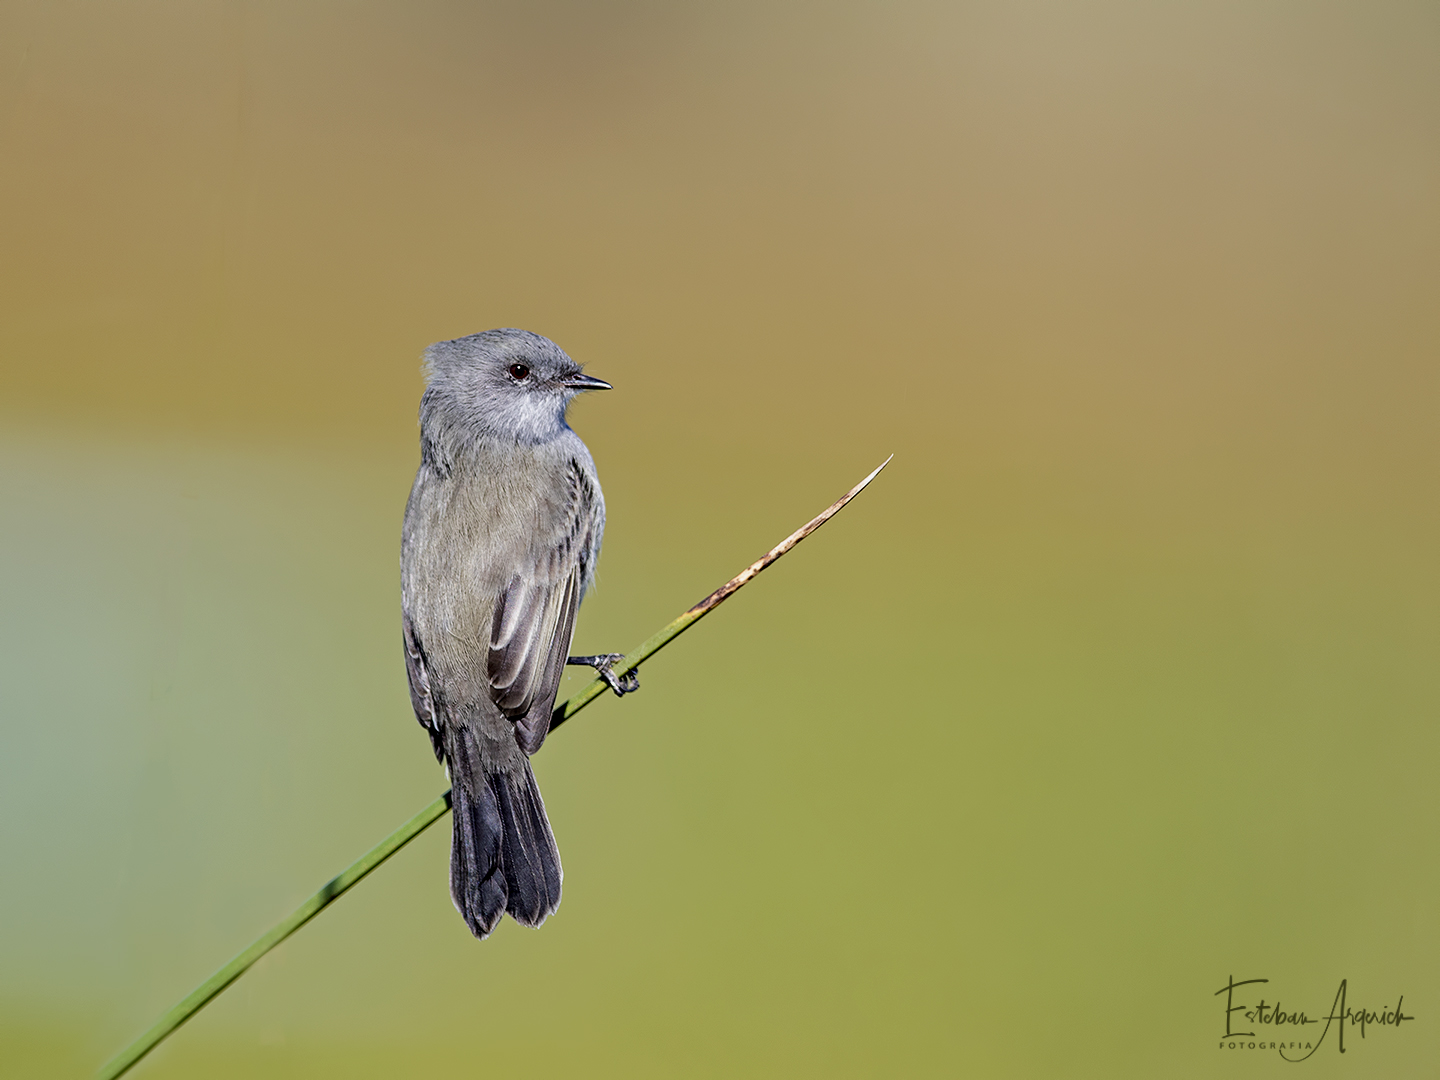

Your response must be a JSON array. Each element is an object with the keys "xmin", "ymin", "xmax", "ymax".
[{"xmin": 446, "ymin": 732, "xmax": 562, "ymax": 937}]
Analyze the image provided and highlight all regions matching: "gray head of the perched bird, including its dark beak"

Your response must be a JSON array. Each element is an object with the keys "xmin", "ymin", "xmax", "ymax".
[{"xmin": 420, "ymin": 328, "xmax": 609, "ymax": 449}]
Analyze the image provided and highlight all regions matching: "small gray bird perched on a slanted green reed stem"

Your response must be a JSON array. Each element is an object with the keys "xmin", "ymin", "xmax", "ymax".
[{"xmin": 400, "ymin": 330, "xmax": 635, "ymax": 937}]
